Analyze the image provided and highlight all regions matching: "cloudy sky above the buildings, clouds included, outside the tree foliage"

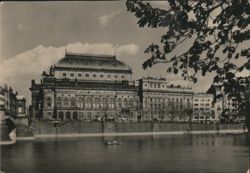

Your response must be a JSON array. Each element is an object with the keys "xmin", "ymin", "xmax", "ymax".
[{"xmin": 0, "ymin": 1, "xmax": 248, "ymax": 101}]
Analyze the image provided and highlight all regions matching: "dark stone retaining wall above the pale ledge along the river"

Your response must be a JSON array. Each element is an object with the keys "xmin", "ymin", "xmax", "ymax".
[{"xmin": 31, "ymin": 121, "xmax": 243, "ymax": 135}]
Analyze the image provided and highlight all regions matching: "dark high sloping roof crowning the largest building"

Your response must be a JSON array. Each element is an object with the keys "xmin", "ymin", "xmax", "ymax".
[{"xmin": 55, "ymin": 53, "xmax": 131, "ymax": 71}]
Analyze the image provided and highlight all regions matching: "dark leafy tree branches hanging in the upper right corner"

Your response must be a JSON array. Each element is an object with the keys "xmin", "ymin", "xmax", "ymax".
[{"xmin": 126, "ymin": 0, "xmax": 250, "ymax": 130}]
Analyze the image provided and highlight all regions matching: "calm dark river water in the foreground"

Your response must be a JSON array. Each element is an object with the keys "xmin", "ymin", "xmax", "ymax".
[{"xmin": 1, "ymin": 134, "xmax": 250, "ymax": 173}]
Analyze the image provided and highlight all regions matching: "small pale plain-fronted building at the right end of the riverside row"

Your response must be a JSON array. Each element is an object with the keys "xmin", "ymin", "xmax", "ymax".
[{"xmin": 193, "ymin": 93, "xmax": 218, "ymax": 122}]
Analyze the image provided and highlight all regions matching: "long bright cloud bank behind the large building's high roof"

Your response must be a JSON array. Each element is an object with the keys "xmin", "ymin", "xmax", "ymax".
[{"xmin": 0, "ymin": 42, "xmax": 139, "ymax": 102}]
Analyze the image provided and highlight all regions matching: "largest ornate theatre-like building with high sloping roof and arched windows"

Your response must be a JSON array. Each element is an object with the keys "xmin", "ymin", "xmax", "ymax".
[{"xmin": 30, "ymin": 53, "xmax": 139, "ymax": 121}]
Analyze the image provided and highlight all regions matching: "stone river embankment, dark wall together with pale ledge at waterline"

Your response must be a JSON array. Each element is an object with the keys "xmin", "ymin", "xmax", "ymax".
[{"xmin": 11, "ymin": 121, "xmax": 247, "ymax": 141}]
